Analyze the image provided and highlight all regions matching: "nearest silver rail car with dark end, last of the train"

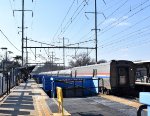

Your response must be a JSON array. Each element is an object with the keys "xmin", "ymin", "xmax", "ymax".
[{"xmin": 72, "ymin": 60, "xmax": 135, "ymax": 92}]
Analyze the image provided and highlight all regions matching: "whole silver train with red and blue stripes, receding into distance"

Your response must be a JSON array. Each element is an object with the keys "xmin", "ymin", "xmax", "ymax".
[{"xmin": 32, "ymin": 60, "xmax": 135, "ymax": 93}]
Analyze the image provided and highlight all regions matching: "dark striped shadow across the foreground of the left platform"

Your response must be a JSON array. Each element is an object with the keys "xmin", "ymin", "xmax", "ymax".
[{"xmin": 0, "ymin": 83, "xmax": 34, "ymax": 116}]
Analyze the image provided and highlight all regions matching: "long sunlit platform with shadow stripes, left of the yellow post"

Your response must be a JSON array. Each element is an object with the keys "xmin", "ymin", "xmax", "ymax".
[{"xmin": 0, "ymin": 79, "xmax": 69, "ymax": 116}]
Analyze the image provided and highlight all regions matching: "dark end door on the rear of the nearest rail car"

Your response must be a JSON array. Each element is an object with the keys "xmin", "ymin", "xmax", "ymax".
[{"xmin": 118, "ymin": 67, "xmax": 129, "ymax": 86}]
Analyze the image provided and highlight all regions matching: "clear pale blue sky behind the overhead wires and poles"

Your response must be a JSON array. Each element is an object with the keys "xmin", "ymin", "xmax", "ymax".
[{"xmin": 0, "ymin": 0, "xmax": 150, "ymax": 65}]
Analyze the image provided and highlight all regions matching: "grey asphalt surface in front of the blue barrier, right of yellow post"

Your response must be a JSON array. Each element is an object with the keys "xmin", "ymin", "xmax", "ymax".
[{"xmin": 60, "ymin": 96, "xmax": 147, "ymax": 116}]
